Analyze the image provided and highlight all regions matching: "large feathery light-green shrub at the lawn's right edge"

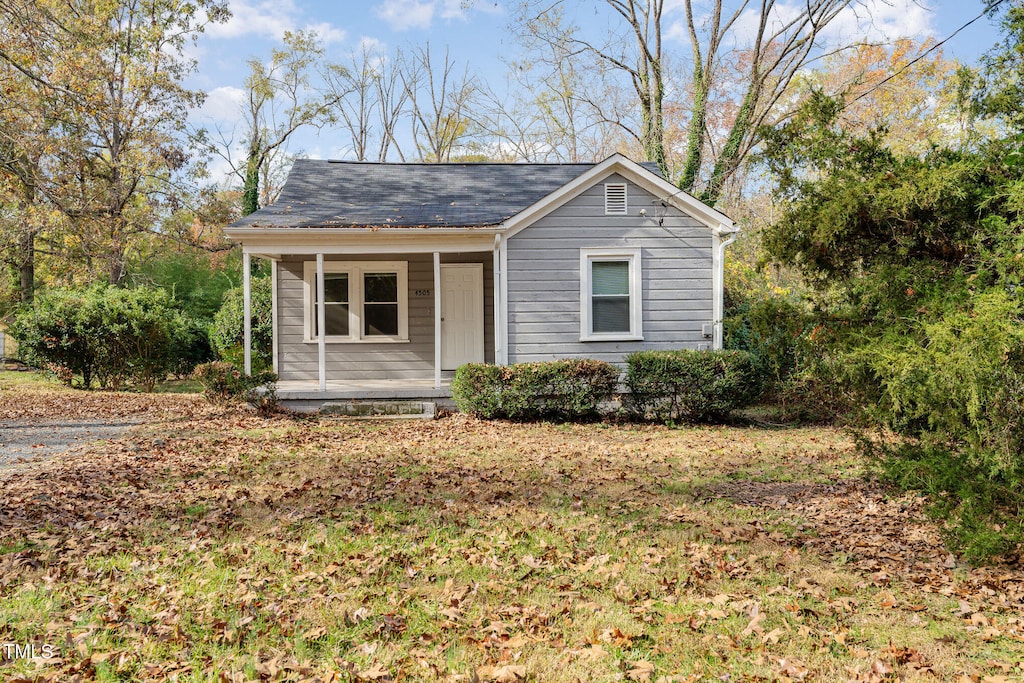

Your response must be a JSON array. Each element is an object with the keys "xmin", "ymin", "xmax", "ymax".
[{"xmin": 846, "ymin": 288, "xmax": 1024, "ymax": 561}]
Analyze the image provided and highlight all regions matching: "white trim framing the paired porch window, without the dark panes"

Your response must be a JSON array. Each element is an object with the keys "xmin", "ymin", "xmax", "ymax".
[{"xmin": 302, "ymin": 261, "xmax": 409, "ymax": 344}]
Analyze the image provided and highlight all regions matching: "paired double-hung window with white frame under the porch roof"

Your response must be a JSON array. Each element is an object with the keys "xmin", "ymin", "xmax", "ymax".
[{"xmin": 303, "ymin": 261, "xmax": 409, "ymax": 342}]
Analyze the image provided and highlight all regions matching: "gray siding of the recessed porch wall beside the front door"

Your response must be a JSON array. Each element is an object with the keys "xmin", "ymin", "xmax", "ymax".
[{"xmin": 276, "ymin": 252, "xmax": 495, "ymax": 381}]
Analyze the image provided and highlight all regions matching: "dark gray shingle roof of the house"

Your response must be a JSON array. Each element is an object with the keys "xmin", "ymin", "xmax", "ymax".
[{"xmin": 231, "ymin": 159, "xmax": 658, "ymax": 227}]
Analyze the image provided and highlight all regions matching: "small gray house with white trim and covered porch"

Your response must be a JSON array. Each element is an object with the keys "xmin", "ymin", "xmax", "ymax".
[{"xmin": 226, "ymin": 155, "xmax": 734, "ymax": 400}]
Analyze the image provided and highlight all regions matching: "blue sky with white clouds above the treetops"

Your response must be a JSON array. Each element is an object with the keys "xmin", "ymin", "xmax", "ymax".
[{"xmin": 190, "ymin": 0, "xmax": 998, "ymax": 180}]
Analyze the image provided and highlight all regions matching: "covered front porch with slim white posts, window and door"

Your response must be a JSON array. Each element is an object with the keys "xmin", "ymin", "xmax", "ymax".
[{"xmin": 243, "ymin": 234, "xmax": 503, "ymax": 410}]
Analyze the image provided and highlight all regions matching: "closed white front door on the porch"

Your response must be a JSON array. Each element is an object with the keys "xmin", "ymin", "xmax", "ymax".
[{"xmin": 441, "ymin": 263, "xmax": 483, "ymax": 370}]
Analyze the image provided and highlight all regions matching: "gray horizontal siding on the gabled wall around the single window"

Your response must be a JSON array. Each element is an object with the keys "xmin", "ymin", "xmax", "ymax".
[{"xmin": 508, "ymin": 175, "xmax": 713, "ymax": 362}]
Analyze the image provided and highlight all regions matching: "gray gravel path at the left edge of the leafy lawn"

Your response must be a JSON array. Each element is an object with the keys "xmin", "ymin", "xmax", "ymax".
[{"xmin": 0, "ymin": 418, "xmax": 142, "ymax": 472}]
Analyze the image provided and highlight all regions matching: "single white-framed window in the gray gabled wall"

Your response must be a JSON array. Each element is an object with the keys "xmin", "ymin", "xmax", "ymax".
[{"xmin": 580, "ymin": 248, "xmax": 643, "ymax": 341}]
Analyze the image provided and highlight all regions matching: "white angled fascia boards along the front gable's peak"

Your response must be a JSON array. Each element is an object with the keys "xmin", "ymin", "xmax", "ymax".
[{"xmin": 503, "ymin": 154, "xmax": 735, "ymax": 238}]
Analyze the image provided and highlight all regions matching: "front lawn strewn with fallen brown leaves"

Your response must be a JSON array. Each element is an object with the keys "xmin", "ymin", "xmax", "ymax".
[{"xmin": 0, "ymin": 376, "xmax": 1024, "ymax": 681}]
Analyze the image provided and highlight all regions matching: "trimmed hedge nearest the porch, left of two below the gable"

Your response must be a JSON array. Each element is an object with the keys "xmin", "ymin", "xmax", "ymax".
[{"xmin": 452, "ymin": 358, "xmax": 620, "ymax": 420}]
